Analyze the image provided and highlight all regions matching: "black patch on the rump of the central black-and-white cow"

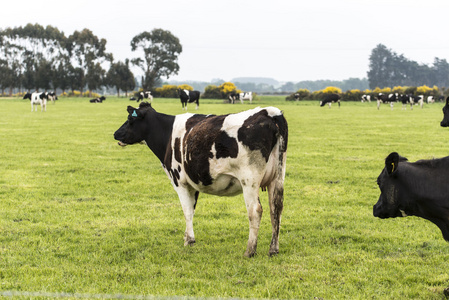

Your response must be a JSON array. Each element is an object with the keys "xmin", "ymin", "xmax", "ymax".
[{"xmin": 238, "ymin": 109, "xmax": 278, "ymax": 161}]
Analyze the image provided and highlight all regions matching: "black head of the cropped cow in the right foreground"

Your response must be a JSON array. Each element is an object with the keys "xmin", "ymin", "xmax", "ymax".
[{"xmin": 373, "ymin": 152, "xmax": 407, "ymax": 219}]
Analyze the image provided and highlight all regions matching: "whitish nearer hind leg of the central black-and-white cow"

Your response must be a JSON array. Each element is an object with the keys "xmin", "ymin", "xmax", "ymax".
[{"xmin": 243, "ymin": 183, "xmax": 263, "ymax": 257}]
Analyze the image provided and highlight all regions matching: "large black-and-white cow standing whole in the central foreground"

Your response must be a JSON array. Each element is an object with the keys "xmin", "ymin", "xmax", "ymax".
[{"xmin": 114, "ymin": 102, "xmax": 288, "ymax": 257}]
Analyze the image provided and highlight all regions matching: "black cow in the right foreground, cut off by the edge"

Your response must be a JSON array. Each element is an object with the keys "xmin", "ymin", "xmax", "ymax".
[{"xmin": 373, "ymin": 152, "xmax": 449, "ymax": 242}]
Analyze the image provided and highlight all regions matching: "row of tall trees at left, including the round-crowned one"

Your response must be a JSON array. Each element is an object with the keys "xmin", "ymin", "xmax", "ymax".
[{"xmin": 0, "ymin": 24, "xmax": 182, "ymax": 94}]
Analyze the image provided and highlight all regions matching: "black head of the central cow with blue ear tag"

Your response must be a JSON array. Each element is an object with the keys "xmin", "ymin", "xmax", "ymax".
[{"xmin": 114, "ymin": 102, "xmax": 152, "ymax": 147}]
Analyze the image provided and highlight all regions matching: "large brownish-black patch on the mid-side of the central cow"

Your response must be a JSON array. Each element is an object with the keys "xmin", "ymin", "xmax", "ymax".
[{"xmin": 183, "ymin": 115, "xmax": 226, "ymax": 186}]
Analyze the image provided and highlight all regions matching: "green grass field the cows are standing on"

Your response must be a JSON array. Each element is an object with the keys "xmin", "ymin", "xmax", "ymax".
[{"xmin": 0, "ymin": 97, "xmax": 449, "ymax": 299}]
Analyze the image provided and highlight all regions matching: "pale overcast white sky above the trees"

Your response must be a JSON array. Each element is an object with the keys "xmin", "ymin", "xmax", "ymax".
[{"xmin": 0, "ymin": 0, "xmax": 449, "ymax": 82}]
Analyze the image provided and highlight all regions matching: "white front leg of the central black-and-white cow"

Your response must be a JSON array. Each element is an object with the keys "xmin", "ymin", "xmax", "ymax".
[{"xmin": 176, "ymin": 188, "xmax": 198, "ymax": 246}]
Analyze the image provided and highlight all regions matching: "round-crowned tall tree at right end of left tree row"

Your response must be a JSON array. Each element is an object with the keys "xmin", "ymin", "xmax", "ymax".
[{"xmin": 131, "ymin": 29, "xmax": 182, "ymax": 90}]
